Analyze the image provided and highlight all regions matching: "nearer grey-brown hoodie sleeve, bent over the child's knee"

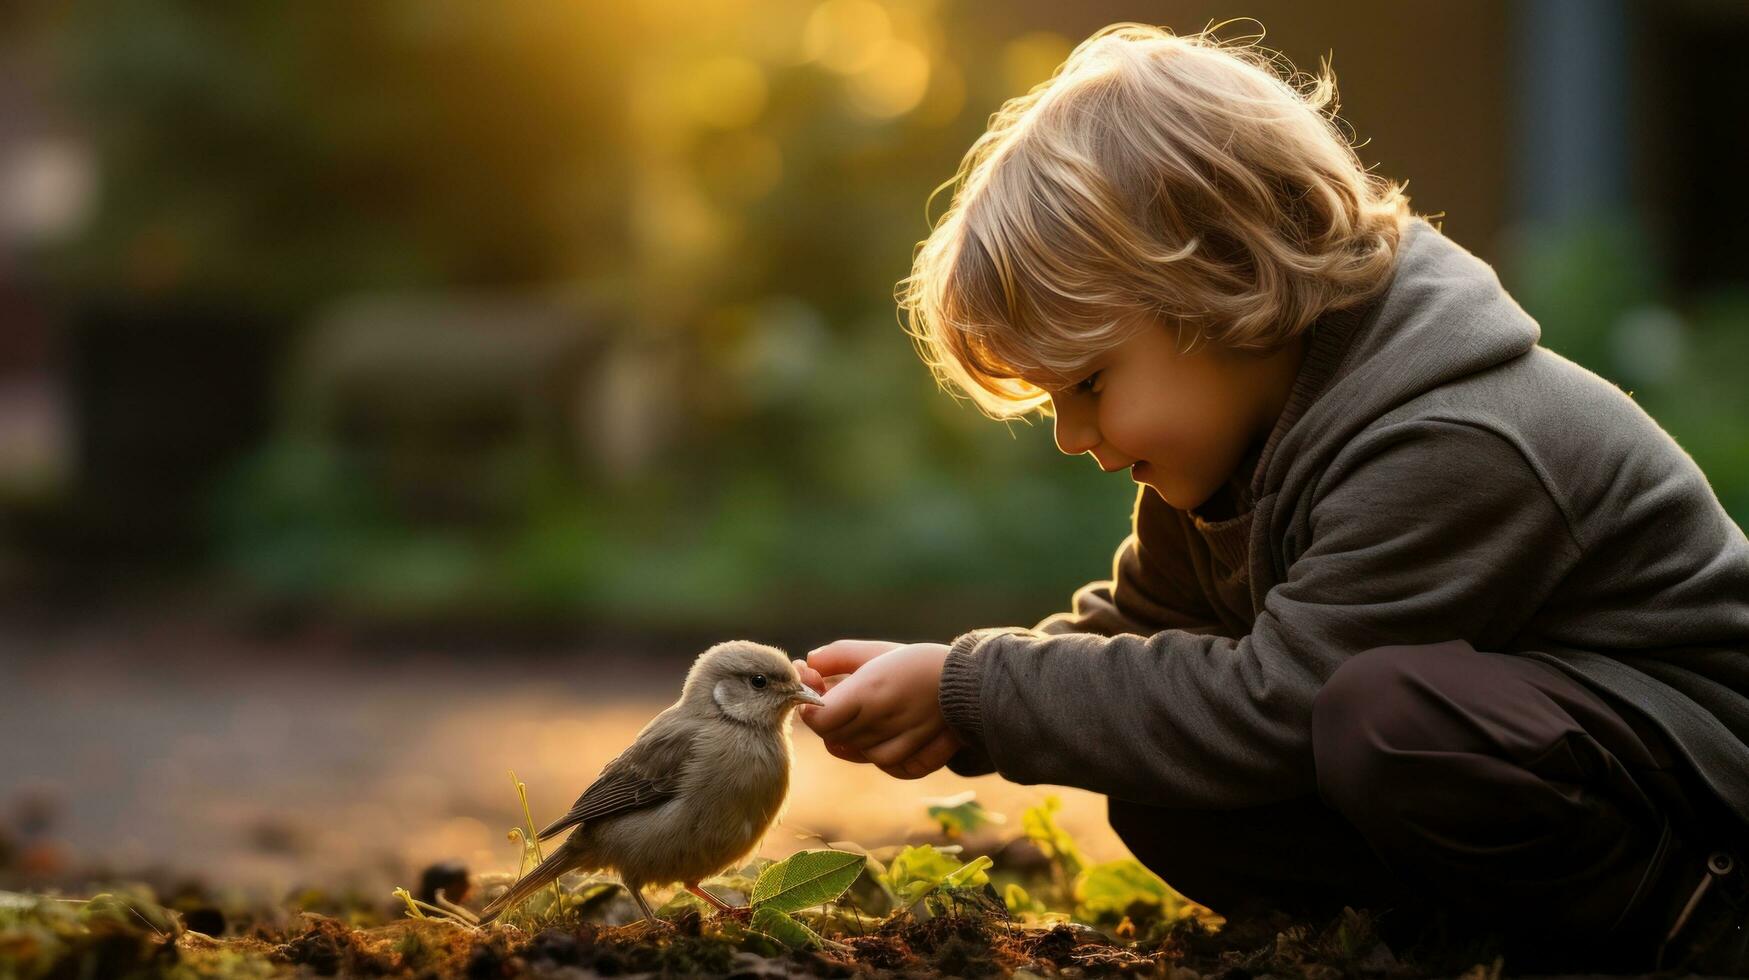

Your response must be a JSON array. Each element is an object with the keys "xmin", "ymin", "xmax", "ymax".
[{"xmin": 941, "ymin": 420, "xmax": 1579, "ymax": 809}]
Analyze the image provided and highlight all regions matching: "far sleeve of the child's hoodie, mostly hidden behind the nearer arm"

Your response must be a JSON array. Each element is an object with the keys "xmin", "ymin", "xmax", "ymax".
[{"xmin": 1034, "ymin": 487, "xmax": 1223, "ymax": 637}]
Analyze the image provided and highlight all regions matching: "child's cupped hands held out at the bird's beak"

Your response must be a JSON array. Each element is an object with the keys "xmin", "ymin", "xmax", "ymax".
[{"xmin": 801, "ymin": 641, "xmax": 962, "ymax": 779}]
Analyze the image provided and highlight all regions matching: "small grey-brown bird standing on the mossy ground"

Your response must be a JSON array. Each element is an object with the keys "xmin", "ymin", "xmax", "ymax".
[{"xmin": 479, "ymin": 641, "xmax": 826, "ymax": 926}]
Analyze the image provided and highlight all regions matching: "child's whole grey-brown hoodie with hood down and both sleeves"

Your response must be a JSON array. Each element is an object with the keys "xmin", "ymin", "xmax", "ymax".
[{"xmin": 941, "ymin": 219, "xmax": 1749, "ymax": 823}]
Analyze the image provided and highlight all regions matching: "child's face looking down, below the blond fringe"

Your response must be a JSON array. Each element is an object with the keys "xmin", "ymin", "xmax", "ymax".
[{"xmin": 1044, "ymin": 320, "xmax": 1305, "ymax": 511}]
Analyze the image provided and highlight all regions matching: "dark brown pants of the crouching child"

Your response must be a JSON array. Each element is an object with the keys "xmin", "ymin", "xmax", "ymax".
[{"xmin": 1109, "ymin": 641, "xmax": 1733, "ymax": 949}]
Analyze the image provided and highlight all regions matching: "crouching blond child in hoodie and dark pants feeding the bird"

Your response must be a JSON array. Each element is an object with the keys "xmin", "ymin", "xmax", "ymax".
[{"xmin": 803, "ymin": 25, "xmax": 1749, "ymax": 968}]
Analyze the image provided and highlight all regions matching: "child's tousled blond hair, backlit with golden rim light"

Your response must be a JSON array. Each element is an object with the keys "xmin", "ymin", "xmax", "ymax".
[{"xmin": 899, "ymin": 25, "xmax": 1411, "ymax": 418}]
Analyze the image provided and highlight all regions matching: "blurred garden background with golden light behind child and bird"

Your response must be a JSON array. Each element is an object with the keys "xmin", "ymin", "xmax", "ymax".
[{"xmin": 0, "ymin": 0, "xmax": 1749, "ymax": 910}]
